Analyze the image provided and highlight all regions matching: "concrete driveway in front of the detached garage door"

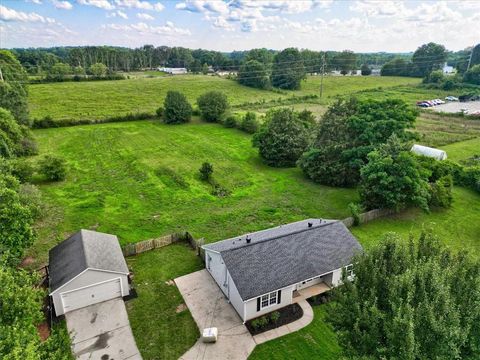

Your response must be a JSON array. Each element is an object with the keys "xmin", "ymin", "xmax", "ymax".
[{"xmin": 65, "ymin": 298, "xmax": 142, "ymax": 360}]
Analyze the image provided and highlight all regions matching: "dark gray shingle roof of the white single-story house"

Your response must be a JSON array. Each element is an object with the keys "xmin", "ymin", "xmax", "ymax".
[{"xmin": 216, "ymin": 219, "xmax": 362, "ymax": 301}]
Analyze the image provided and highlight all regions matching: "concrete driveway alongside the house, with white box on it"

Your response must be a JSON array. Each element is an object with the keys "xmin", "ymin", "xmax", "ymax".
[{"xmin": 175, "ymin": 270, "xmax": 255, "ymax": 360}]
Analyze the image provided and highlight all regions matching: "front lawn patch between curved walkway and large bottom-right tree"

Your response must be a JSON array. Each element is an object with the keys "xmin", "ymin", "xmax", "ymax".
[{"xmin": 249, "ymin": 305, "xmax": 341, "ymax": 360}]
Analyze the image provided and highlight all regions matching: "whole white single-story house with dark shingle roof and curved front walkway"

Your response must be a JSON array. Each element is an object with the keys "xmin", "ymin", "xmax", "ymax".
[{"xmin": 202, "ymin": 219, "xmax": 362, "ymax": 321}]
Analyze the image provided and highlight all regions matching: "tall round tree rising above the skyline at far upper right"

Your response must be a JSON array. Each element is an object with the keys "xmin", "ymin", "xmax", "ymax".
[{"xmin": 412, "ymin": 42, "xmax": 448, "ymax": 77}]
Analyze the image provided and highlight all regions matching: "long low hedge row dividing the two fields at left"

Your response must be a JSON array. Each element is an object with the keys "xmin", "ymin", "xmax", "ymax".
[{"xmin": 32, "ymin": 112, "xmax": 157, "ymax": 129}]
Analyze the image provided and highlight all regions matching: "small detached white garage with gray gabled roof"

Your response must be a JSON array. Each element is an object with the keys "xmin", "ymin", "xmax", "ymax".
[{"xmin": 48, "ymin": 230, "xmax": 130, "ymax": 316}]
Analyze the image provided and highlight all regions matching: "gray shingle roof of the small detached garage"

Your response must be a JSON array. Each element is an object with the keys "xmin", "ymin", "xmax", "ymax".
[{"xmin": 48, "ymin": 229, "xmax": 128, "ymax": 291}]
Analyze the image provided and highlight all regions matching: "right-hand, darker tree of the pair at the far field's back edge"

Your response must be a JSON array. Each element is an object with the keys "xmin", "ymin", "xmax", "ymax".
[{"xmin": 272, "ymin": 48, "xmax": 306, "ymax": 90}]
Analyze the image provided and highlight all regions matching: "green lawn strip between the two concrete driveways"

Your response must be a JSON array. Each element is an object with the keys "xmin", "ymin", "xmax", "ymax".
[{"xmin": 126, "ymin": 244, "xmax": 202, "ymax": 360}]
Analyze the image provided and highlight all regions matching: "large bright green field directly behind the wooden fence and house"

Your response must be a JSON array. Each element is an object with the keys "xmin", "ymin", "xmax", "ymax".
[{"xmin": 29, "ymin": 121, "xmax": 357, "ymax": 264}]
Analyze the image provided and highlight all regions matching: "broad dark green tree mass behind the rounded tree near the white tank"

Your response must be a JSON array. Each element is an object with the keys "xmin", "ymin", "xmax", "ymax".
[{"xmin": 299, "ymin": 98, "xmax": 416, "ymax": 186}]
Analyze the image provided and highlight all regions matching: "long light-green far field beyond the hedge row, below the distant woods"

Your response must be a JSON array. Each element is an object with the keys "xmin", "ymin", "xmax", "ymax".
[{"xmin": 29, "ymin": 75, "xmax": 420, "ymax": 120}]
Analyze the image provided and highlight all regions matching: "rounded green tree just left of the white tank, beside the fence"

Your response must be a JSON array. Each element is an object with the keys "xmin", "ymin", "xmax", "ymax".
[{"xmin": 360, "ymin": 135, "xmax": 430, "ymax": 211}]
